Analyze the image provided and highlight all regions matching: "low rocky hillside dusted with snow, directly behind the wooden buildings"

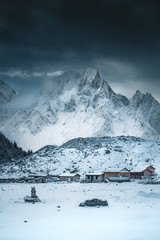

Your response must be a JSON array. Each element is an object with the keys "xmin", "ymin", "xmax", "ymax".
[{"xmin": 1, "ymin": 136, "xmax": 160, "ymax": 177}]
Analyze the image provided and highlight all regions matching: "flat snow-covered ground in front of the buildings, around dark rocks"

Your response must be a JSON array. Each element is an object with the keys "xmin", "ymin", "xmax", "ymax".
[{"xmin": 0, "ymin": 182, "xmax": 160, "ymax": 240}]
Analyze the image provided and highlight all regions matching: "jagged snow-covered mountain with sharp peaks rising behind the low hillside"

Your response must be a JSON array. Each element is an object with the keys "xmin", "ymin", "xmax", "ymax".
[{"xmin": 0, "ymin": 68, "xmax": 160, "ymax": 151}]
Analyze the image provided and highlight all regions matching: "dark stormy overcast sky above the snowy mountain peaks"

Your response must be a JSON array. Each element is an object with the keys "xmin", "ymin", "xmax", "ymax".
[{"xmin": 0, "ymin": 0, "xmax": 160, "ymax": 101}]
